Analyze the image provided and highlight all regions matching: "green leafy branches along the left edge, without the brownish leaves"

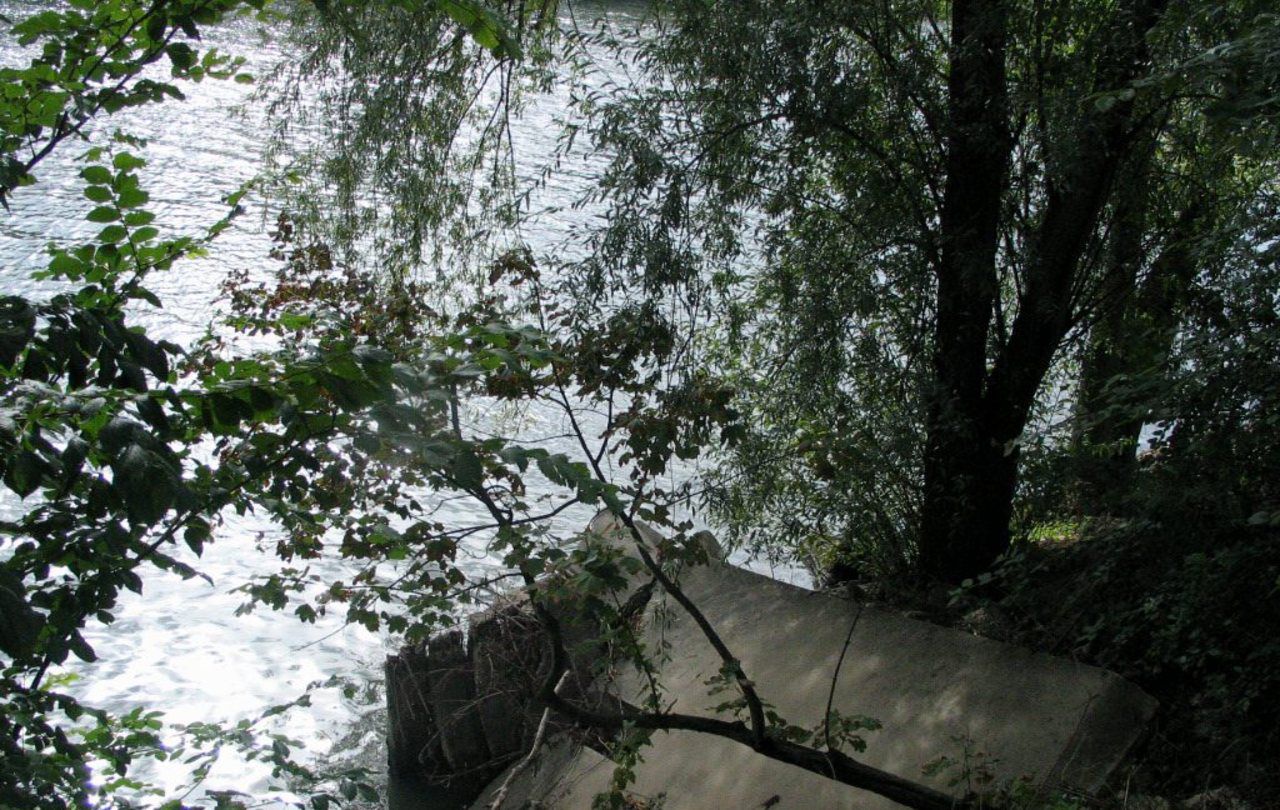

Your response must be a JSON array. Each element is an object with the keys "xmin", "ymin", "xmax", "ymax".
[{"xmin": 0, "ymin": 0, "xmax": 522, "ymax": 807}]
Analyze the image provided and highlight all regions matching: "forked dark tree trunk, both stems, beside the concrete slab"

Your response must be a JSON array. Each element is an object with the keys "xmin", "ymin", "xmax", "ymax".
[{"xmin": 919, "ymin": 0, "xmax": 1165, "ymax": 582}]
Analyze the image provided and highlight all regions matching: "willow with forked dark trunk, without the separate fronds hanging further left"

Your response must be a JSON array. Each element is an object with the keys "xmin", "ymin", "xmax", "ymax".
[{"xmin": 552, "ymin": 0, "xmax": 1274, "ymax": 582}]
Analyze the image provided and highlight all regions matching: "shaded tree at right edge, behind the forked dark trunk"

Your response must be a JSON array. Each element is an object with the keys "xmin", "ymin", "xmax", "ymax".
[{"xmin": 1069, "ymin": 17, "xmax": 1277, "ymax": 514}]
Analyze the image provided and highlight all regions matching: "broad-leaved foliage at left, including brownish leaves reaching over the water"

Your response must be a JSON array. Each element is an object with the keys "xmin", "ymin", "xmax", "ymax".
[{"xmin": 0, "ymin": 0, "xmax": 752, "ymax": 810}]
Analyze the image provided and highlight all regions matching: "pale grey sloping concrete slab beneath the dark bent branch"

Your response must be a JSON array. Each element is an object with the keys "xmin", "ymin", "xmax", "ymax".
[{"xmin": 476, "ymin": 518, "xmax": 1156, "ymax": 810}]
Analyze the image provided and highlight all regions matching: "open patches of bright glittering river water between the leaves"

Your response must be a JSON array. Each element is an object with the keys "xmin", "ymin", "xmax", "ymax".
[{"xmin": 0, "ymin": 0, "xmax": 798, "ymax": 798}]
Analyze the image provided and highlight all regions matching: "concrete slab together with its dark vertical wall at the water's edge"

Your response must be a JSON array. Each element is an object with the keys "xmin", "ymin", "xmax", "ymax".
[{"xmin": 388, "ymin": 516, "xmax": 1156, "ymax": 810}]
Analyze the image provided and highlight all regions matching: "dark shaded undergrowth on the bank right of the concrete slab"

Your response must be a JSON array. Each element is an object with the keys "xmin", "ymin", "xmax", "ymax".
[{"xmin": 956, "ymin": 520, "xmax": 1280, "ymax": 807}]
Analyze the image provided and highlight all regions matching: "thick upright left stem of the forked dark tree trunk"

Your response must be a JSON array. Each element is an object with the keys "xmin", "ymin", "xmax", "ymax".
[{"xmin": 920, "ymin": 0, "xmax": 1012, "ymax": 580}]
